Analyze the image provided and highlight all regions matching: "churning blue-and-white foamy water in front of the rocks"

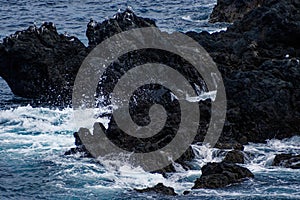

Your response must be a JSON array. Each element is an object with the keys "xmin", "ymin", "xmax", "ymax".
[{"xmin": 0, "ymin": 106, "xmax": 300, "ymax": 199}]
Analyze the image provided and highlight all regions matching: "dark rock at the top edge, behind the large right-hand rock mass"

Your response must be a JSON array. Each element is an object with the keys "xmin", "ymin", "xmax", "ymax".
[{"xmin": 209, "ymin": 0, "xmax": 264, "ymax": 23}]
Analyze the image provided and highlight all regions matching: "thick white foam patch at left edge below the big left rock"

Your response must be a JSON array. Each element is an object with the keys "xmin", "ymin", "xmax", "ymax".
[{"xmin": 0, "ymin": 106, "xmax": 76, "ymax": 156}]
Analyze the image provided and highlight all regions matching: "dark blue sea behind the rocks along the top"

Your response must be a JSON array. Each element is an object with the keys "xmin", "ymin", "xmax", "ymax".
[{"xmin": 0, "ymin": 0, "xmax": 224, "ymax": 43}]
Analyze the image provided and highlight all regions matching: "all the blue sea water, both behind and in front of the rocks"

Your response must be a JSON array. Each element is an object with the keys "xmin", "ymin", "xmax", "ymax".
[{"xmin": 0, "ymin": 0, "xmax": 300, "ymax": 200}]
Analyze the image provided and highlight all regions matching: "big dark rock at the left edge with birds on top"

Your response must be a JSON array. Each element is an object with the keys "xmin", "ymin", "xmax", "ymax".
[{"xmin": 0, "ymin": 23, "xmax": 88, "ymax": 105}]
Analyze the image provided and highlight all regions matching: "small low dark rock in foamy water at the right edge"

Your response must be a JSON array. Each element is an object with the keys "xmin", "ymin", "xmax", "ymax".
[{"xmin": 273, "ymin": 154, "xmax": 300, "ymax": 169}]
